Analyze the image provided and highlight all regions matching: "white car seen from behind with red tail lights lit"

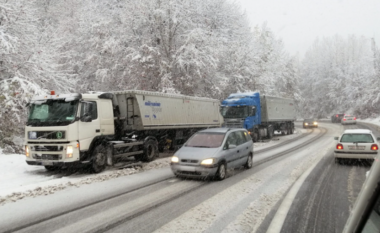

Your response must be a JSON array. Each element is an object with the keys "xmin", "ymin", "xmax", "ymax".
[{"xmin": 334, "ymin": 129, "xmax": 380, "ymax": 163}]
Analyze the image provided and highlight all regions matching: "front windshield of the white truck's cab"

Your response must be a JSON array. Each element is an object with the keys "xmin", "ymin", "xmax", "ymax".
[{"xmin": 27, "ymin": 100, "xmax": 79, "ymax": 126}]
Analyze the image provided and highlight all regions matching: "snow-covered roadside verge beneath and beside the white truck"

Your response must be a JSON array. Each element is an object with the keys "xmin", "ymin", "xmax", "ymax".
[{"xmin": 0, "ymin": 154, "xmax": 170, "ymax": 205}]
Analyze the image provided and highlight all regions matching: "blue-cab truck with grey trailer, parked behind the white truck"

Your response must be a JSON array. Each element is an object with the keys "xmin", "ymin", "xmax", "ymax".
[{"xmin": 221, "ymin": 92, "xmax": 296, "ymax": 142}]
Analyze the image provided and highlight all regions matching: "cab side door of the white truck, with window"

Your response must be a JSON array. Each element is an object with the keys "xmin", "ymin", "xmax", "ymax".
[{"xmin": 78, "ymin": 101, "xmax": 101, "ymax": 151}]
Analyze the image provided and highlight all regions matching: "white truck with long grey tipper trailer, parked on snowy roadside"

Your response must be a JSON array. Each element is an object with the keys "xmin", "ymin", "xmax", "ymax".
[{"xmin": 25, "ymin": 90, "xmax": 223, "ymax": 173}]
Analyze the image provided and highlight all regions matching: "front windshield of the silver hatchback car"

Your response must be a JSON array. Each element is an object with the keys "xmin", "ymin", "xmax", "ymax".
[{"xmin": 185, "ymin": 133, "xmax": 225, "ymax": 148}]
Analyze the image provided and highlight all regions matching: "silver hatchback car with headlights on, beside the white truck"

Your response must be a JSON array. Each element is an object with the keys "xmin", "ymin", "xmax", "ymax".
[{"xmin": 170, "ymin": 128, "xmax": 253, "ymax": 180}]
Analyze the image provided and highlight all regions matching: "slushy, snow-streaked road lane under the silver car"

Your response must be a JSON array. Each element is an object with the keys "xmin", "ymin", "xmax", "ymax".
[{"xmin": 0, "ymin": 124, "xmax": 332, "ymax": 232}]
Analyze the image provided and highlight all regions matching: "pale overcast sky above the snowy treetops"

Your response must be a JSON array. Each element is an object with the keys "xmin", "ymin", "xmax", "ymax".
[{"xmin": 236, "ymin": 0, "xmax": 380, "ymax": 57}]
